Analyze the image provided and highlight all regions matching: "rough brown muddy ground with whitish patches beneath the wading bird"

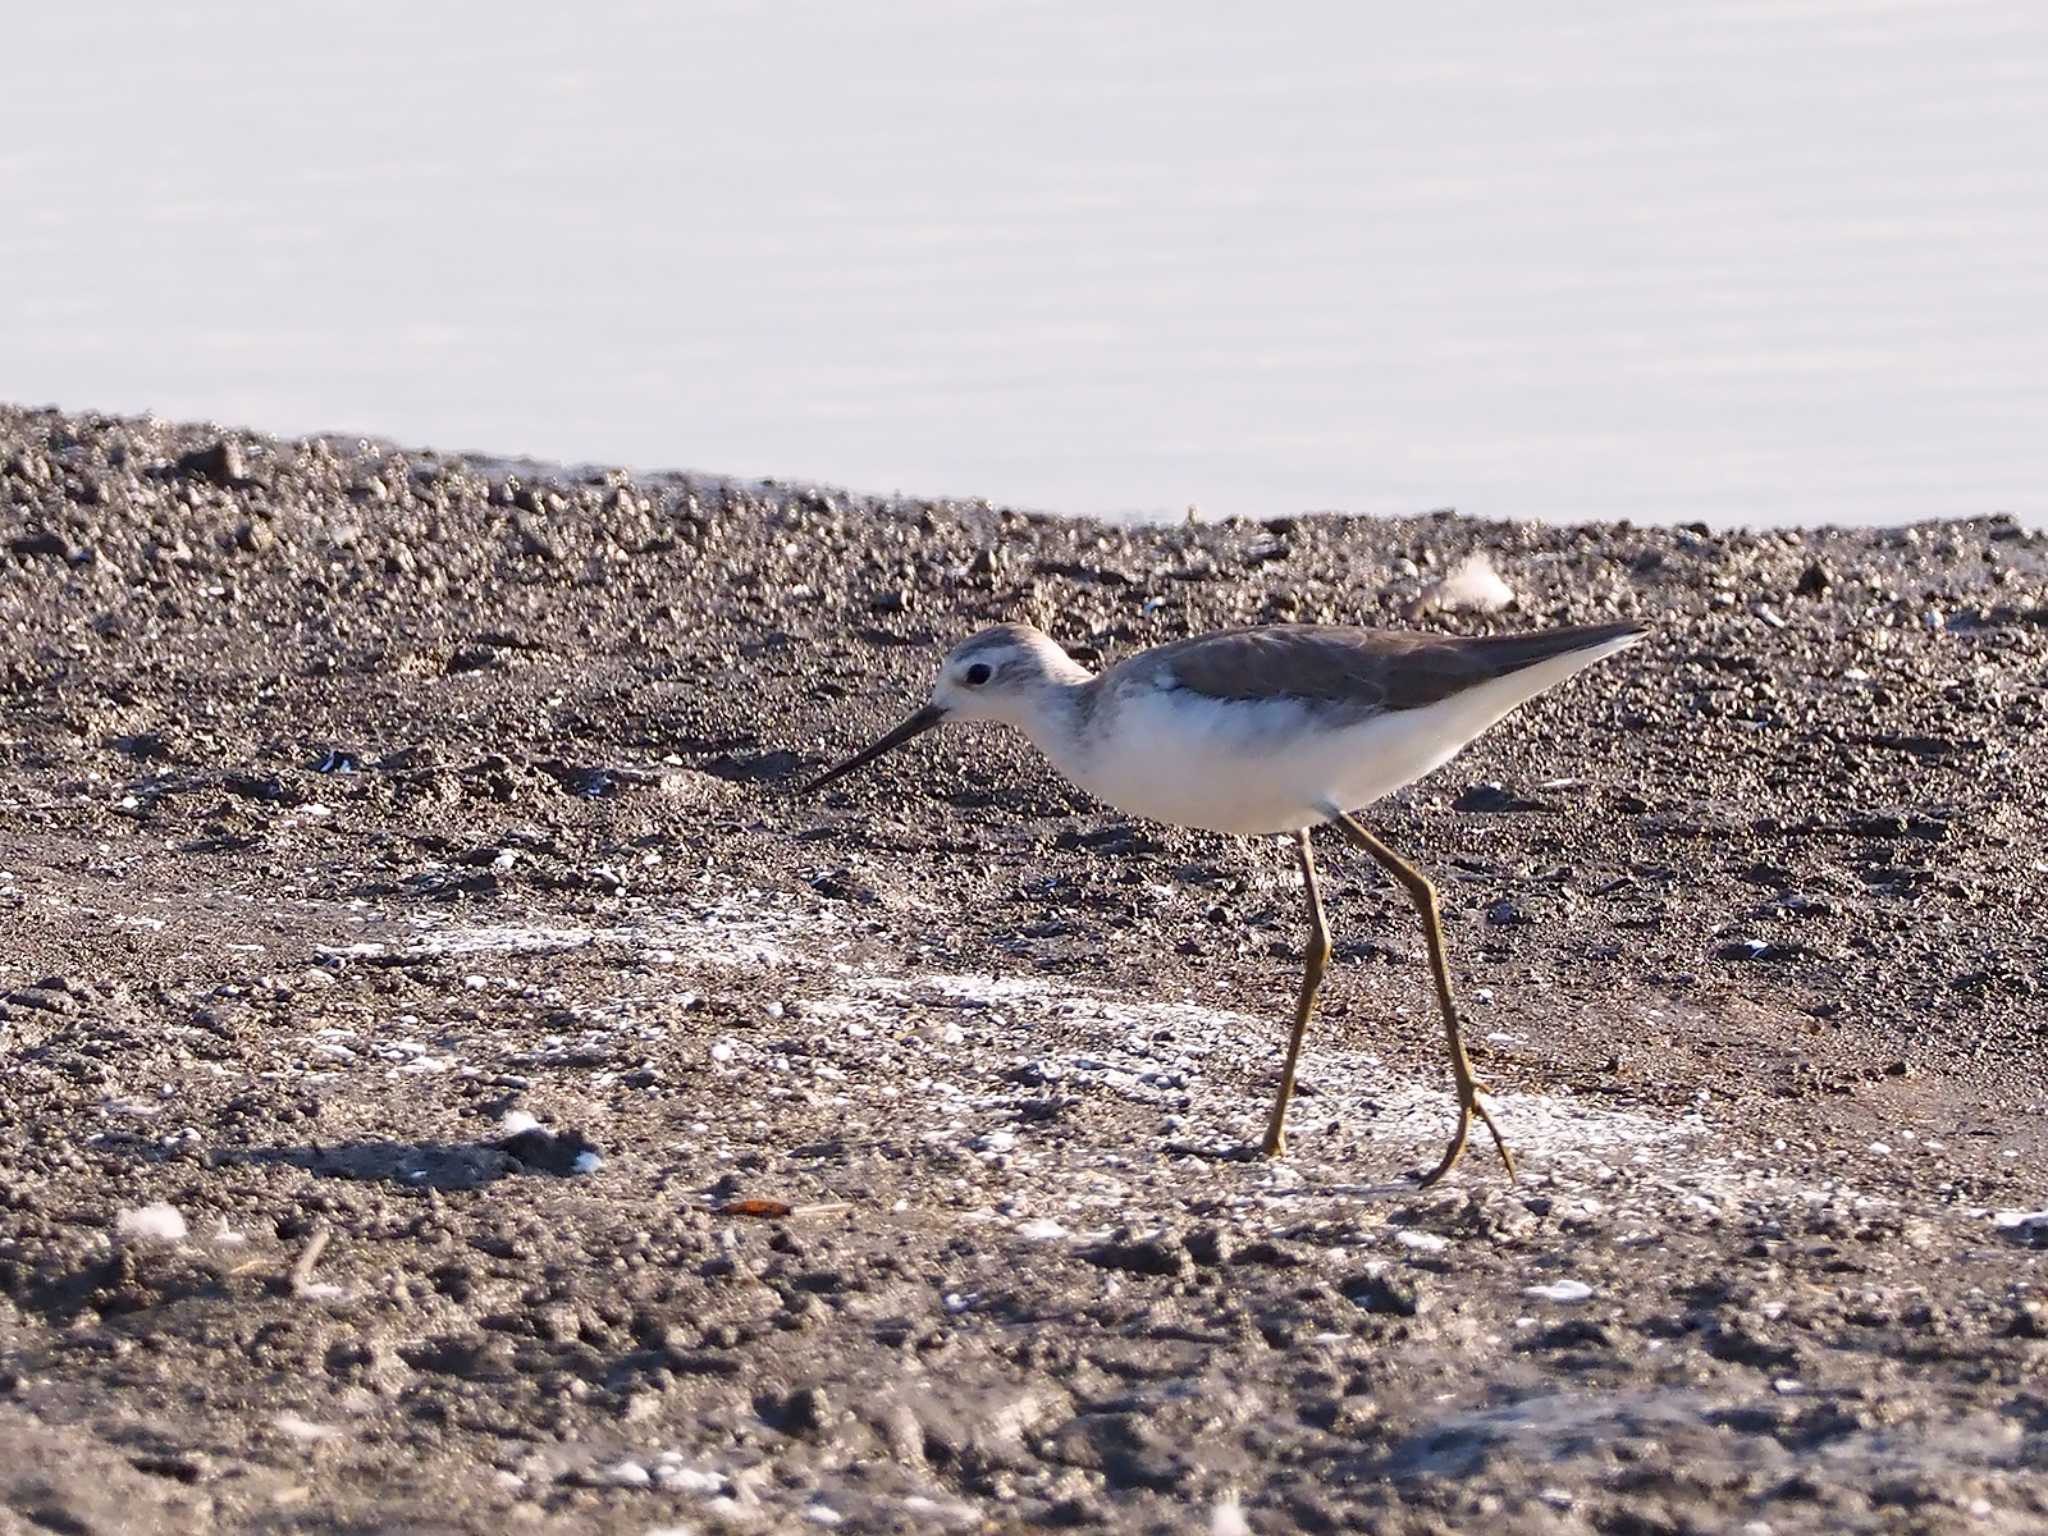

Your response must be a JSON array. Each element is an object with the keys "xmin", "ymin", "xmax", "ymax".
[{"xmin": 0, "ymin": 410, "xmax": 2048, "ymax": 1536}]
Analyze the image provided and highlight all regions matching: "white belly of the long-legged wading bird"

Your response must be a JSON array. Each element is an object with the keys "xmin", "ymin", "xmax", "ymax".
[{"xmin": 1049, "ymin": 690, "xmax": 1470, "ymax": 834}]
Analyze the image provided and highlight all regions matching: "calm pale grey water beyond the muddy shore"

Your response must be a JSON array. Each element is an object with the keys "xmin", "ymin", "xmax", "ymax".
[{"xmin": 0, "ymin": 0, "xmax": 2048, "ymax": 522}]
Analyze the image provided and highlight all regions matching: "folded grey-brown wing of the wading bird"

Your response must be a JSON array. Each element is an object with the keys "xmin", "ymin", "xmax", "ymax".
[{"xmin": 1116, "ymin": 625, "xmax": 1642, "ymax": 715}]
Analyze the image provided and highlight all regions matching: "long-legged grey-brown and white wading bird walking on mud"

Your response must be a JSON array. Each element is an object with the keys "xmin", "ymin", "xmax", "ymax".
[{"xmin": 801, "ymin": 625, "xmax": 1645, "ymax": 1184}]
